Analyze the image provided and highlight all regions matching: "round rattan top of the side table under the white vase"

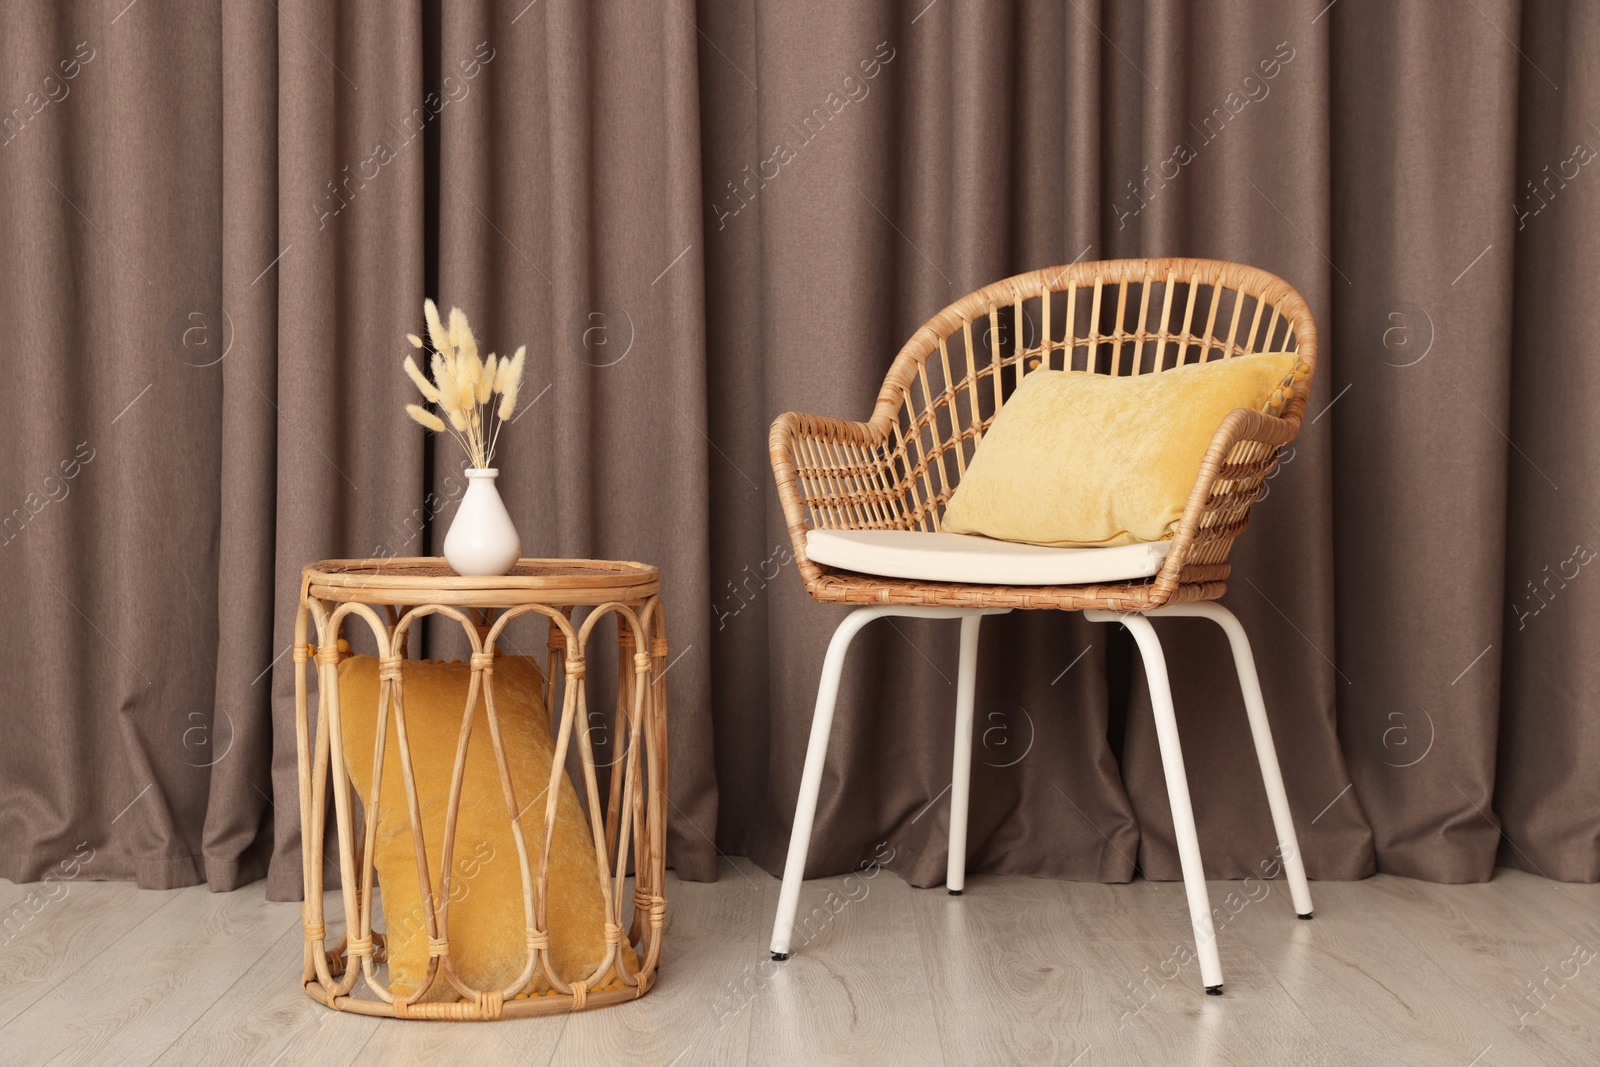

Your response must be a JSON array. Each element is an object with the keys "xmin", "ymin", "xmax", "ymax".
[{"xmin": 301, "ymin": 557, "xmax": 661, "ymax": 608}]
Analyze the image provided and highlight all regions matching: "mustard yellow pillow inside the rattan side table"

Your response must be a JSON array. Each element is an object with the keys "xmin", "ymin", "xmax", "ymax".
[{"xmin": 339, "ymin": 656, "xmax": 638, "ymax": 1001}]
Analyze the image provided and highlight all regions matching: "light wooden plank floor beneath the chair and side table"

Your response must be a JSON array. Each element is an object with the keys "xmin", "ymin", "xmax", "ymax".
[{"xmin": 0, "ymin": 859, "xmax": 1600, "ymax": 1067}]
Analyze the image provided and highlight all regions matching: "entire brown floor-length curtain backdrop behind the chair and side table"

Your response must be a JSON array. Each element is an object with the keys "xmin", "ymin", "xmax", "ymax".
[{"xmin": 0, "ymin": 0, "xmax": 1600, "ymax": 897}]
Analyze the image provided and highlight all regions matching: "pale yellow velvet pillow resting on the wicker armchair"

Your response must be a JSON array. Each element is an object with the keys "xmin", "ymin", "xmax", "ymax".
[{"xmin": 941, "ymin": 352, "xmax": 1309, "ymax": 549}]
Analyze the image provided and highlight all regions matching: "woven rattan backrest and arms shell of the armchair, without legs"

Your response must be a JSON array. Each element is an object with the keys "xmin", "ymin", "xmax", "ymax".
[{"xmin": 770, "ymin": 259, "xmax": 1317, "ymax": 611}]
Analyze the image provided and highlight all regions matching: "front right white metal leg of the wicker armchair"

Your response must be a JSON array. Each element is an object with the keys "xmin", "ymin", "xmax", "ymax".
[{"xmin": 1085, "ymin": 611, "xmax": 1222, "ymax": 995}]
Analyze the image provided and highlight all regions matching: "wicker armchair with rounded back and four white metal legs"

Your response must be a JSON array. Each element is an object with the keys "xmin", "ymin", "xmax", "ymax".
[{"xmin": 770, "ymin": 259, "xmax": 1317, "ymax": 993}]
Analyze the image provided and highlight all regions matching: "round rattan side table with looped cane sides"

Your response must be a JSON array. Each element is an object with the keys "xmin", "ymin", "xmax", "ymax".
[{"xmin": 294, "ymin": 558, "xmax": 667, "ymax": 1021}]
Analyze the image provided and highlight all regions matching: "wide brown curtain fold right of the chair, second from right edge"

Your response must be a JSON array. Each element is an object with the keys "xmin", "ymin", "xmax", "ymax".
[{"xmin": 1330, "ymin": 5, "xmax": 1523, "ymax": 881}]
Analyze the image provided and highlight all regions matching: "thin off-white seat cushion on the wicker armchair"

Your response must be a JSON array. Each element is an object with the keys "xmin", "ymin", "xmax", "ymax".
[{"xmin": 805, "ymin": 530, "xmax": 1171, "ymax": 585}]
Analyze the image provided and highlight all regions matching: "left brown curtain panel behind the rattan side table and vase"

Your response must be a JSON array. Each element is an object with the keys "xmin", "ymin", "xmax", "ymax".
[{"xmin": 0, "ymin": 0, "xmax": 717, "ymax": 897}]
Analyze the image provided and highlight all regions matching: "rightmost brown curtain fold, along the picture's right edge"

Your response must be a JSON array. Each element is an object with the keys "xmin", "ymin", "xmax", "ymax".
[{"xmin": 1497, "ymin": 3, "xmax": 1600, "ymax": 881}]
